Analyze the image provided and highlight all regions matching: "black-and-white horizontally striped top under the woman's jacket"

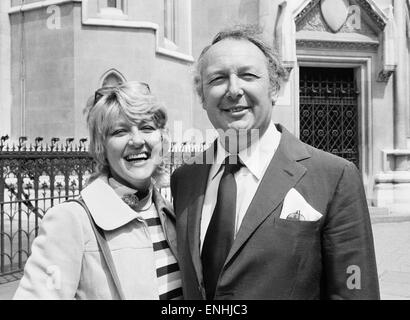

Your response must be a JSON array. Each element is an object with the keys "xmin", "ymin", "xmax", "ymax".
[{"xmin": 139, "ymin": 204, "xmax": 182, "ymax": 300}]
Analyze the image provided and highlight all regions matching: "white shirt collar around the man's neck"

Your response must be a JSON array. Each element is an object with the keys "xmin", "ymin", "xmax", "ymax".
[{"xmin": 210, "ymin": 122, "xmax": 281, "ymax": 180}]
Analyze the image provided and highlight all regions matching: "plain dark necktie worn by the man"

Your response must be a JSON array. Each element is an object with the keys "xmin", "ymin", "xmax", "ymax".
[{"xmin": 201, "ymin": 156, "xmax": 242, "ymax": 300}]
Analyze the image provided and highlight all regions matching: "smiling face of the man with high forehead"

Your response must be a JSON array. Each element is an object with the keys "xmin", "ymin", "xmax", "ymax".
[{"xmin": 201, "ymin": 39, "xmax": 272, "ymax": 136}]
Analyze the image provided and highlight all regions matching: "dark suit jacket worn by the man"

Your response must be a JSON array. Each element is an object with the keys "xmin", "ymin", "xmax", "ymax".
[{"xmin": 171, "ymin": 125, "xmax": 379, "ymax": 299}]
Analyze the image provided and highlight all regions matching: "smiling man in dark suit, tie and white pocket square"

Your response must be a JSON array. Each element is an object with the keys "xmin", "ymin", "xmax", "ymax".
[{"xmin": 171, "ymin": 27, "xmax": 379, "ymax": 299}]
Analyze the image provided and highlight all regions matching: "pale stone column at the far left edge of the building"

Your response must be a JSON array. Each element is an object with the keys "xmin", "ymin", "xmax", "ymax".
[{"xmin": 0, "ymin": 1, "xmax": 11, "ymax": 136}]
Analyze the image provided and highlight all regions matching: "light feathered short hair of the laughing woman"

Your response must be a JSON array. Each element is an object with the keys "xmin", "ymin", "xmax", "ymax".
[{"xmin": 84, "ymin": 81, "xmax": 168, "ymax": 186}]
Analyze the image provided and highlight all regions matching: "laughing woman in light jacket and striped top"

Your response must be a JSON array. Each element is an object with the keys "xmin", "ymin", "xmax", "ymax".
[{"xmin": 14, "ymin": 82, "xmax": 182, "ymax": 300}]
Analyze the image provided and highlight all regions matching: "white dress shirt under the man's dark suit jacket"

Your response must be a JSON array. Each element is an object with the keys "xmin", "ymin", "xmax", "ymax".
[{"xmin": 200, "ymin": 122, "xmax": 281, "ymax": 252}]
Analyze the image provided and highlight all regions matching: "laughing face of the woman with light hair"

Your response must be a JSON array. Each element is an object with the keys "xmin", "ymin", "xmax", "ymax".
[{"xmin": 105, "ymin": 117, "xmax": 162, "ymax": 190}]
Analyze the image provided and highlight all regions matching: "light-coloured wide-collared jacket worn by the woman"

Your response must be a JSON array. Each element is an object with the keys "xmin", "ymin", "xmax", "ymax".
[{"xmin": 14, "ymin": 177, "xmax": 176, "ymax": 300}]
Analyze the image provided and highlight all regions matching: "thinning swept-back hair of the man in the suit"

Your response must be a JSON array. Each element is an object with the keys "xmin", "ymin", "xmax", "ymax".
[{"xmin": 194, "ymin": 25, "xmax": 287, "ymax": 103}]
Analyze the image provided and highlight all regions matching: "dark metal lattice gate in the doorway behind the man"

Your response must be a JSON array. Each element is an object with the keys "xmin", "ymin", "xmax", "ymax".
[{"xmin": 300, "ymin": 67, "xmax": 360, "ymax": 167}]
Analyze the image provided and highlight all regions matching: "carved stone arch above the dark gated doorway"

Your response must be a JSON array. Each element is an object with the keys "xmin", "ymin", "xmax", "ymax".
[{"xmin": 292, "ymin": 0, "xmax": 397, "ymax": 82}]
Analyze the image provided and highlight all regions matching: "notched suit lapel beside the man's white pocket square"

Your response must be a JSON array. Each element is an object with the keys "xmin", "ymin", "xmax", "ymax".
[{"xmin": 225, "ymin": 127, "xmax": 310, "ymax": 264}]
